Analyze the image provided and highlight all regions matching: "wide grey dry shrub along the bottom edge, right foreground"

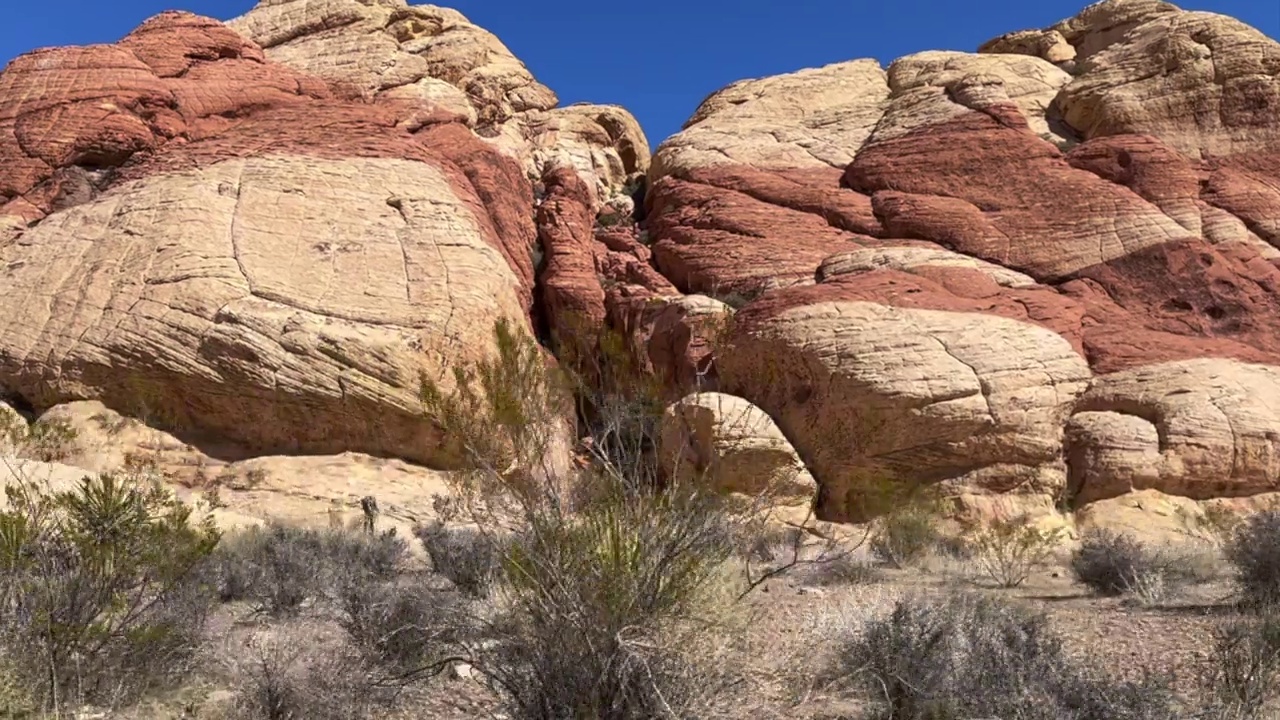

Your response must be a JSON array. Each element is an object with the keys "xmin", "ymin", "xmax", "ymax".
[{"xmin": 835, "ymin": 594, "xmax": 1175, "ymax": 720}]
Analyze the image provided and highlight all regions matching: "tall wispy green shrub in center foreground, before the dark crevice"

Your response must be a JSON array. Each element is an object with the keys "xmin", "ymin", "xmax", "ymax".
[{"xmin": 422, "ymin": 323, "xmax": 778, "ymax": 720}]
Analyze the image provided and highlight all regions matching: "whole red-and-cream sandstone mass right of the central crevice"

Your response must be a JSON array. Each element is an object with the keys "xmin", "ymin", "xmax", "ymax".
[{"xmin": 646, "ymin": 0, "xmax": 1280, "ymax": 519}]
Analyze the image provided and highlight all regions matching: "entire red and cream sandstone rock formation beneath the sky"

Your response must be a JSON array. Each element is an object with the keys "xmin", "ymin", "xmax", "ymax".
[{"xmin": 0, "ymin": 0, "xmax": 1280, "ymax": 530}]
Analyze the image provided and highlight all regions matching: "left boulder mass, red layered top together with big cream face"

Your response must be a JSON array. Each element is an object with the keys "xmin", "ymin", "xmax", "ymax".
[{"xmin": 0, "ymin": 13, "xmax": 535, "ymax": 461}]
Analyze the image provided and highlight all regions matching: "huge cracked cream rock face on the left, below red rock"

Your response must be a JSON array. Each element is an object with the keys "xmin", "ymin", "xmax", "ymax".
[{"xmin": 0, "ymin": 156, "xmax": 524, "ymax": 461}]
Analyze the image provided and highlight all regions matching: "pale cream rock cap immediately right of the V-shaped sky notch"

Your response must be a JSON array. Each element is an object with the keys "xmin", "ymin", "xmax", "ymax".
[{"xmin": 649, "ymin": 60, "xmax": 890, "ymax": 183}]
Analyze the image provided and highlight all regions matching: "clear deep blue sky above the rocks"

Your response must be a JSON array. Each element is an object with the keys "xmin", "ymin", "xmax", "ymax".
[{"xmin": 0, "ymin": 0, "xmax": 1280, "ymax": 146}]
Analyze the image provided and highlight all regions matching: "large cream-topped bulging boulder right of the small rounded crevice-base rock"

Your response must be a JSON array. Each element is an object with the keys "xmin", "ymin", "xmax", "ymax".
[{"xmin": 718, "ymin": 302, "xmax": 1091, "ymax": 520}]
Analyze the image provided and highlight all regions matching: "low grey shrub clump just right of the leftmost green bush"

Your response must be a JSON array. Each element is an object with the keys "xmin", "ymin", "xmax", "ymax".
[{"xmin": 214, "ymin": 523, "xmax": 407, "ymax": 615}]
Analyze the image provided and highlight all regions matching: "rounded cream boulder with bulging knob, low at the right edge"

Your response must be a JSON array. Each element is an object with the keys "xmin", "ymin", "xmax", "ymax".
[{"xmin": 1066, "ymin": 359, "xmax": 1280, "ymax": 505}]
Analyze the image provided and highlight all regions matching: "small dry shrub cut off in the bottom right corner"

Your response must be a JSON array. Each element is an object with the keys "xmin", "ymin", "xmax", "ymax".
[{"xmin": 1203, "ymin": 614, "xmax": 1280, "ymax": 719}]
